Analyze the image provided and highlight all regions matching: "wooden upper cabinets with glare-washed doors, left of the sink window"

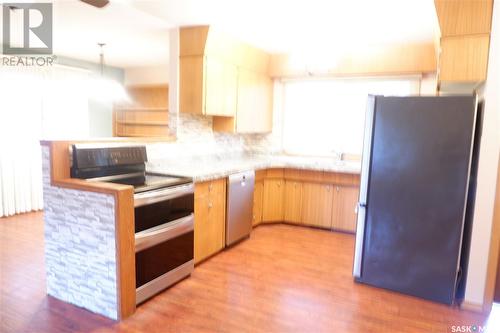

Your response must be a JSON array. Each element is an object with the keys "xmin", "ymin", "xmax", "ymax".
[{"xmin": 179, "ymin": 26, "xmax": 273, "ymax": 133}]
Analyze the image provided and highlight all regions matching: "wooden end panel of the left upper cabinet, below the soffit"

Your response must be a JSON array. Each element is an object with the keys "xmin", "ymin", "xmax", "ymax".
[{"xmin": 179, "ymin": 56, "xmax": 205, "ymax": 114}]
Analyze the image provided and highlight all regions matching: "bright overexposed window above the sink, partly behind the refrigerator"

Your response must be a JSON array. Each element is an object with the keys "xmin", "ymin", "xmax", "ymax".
[{"xmin": 283, "ymin": 77, "xmax": 420, "ymax": 155}]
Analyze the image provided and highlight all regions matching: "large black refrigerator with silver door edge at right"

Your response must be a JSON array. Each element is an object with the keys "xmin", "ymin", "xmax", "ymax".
[{"xmin": 353, "ymin": 96, "xmax": 478, "ymax": 304}]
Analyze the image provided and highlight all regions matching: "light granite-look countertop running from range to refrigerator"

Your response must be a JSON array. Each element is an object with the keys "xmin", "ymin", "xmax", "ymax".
[{"xmin": 147, "ymin": 155, "xmax": 361, "ymax": 182}]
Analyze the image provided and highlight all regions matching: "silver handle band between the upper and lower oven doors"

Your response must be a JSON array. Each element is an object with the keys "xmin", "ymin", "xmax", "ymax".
[{"xmin": 135, "ymin": 213, "xmax": 194, "ymax": 252}]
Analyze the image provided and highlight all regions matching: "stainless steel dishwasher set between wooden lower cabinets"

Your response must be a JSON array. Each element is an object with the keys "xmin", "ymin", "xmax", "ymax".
[{"xmin": 226, "ymin": 170, "xmax": 255, "ymax": 245}]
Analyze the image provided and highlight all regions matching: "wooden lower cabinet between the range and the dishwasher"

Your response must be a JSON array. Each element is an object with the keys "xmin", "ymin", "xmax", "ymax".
[{"xmin": 194, "ymin": 178, "xmax": 226, "ymax": 263}]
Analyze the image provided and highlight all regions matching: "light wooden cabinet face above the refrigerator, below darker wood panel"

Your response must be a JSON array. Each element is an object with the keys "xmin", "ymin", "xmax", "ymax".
[{"xmin": 439, "ymin": 34, "xmax": 490, "ymax": 82}]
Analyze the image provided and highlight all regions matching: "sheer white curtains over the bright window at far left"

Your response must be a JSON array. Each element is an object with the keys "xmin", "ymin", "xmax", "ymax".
[{"xmin": 0, "ymin": 67, "xmax": 89, "ymax": 217}]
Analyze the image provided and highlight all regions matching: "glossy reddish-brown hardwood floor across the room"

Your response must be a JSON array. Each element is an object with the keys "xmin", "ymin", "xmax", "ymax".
[{"xmin": 0, "ymin": 213, "xmax": 500, "ymax": 333}]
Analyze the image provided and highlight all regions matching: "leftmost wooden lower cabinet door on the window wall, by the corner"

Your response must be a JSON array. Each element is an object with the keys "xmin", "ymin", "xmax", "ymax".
[{"xmin": 262, "ymin": 179, "xmax": 285, "ymax": 222}]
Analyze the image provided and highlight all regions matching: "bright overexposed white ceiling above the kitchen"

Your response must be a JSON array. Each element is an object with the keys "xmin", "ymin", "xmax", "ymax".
[{"xmin": 0, "ymin": 0, "xmax": 437, "ymax": 67}]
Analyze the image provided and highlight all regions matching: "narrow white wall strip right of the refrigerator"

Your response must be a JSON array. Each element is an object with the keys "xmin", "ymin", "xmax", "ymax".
[{"xmin": 465, "ymin": 2, "xmax": 500, "ymax": 305}]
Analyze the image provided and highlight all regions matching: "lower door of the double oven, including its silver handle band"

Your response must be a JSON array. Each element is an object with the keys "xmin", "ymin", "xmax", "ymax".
[{"xmin": 135, "ymin": 213, "xmax": 194, "ymax": 304}]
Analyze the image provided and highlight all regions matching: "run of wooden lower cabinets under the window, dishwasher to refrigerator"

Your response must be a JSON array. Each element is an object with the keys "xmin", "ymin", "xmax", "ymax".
[{"xmin": 253, "ymin": 169, "xmax": 359, "ymax": 233}]
